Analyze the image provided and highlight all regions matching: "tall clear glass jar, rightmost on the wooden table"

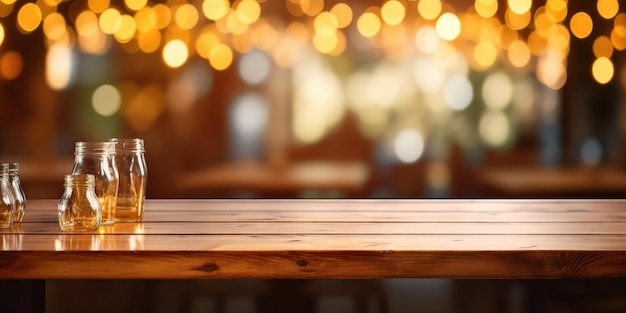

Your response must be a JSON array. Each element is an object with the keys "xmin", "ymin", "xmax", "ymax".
[{"xmin": 109, "ymin": 138, "xmax": 148, "ymax": 222}]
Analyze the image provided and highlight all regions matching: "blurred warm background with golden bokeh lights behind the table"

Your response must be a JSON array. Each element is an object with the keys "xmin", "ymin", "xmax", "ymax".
[{"xmin": 0, "ymin": 0, "xmax": 626, "ymax": 198}]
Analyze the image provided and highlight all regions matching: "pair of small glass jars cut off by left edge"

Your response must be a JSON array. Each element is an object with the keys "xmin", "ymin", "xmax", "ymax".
[{"xmin": 0, "ymin": 163, "xmax": 26, "ymax": 228}]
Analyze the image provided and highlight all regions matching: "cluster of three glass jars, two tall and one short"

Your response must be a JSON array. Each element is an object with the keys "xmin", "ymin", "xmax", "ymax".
[{"xmin": 58, "ymin": 138, "xmax": 147, "ymax": 231}]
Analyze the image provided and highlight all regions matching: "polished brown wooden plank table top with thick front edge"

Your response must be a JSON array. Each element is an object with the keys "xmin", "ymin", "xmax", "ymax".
[{"xmin": 0, "ymin": 199, "xmax": 626, "ymax": 279}]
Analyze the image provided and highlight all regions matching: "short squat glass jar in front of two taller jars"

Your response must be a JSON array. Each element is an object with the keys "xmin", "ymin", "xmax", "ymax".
[{"xmin": 58, "ymin": 174, "xmax": 102, "ymax": 231}]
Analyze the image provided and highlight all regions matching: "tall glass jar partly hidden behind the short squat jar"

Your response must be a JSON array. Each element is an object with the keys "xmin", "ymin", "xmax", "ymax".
[{"xmin": 72, "ymin": 142, "xmax": 119, "ymax": 225}]
